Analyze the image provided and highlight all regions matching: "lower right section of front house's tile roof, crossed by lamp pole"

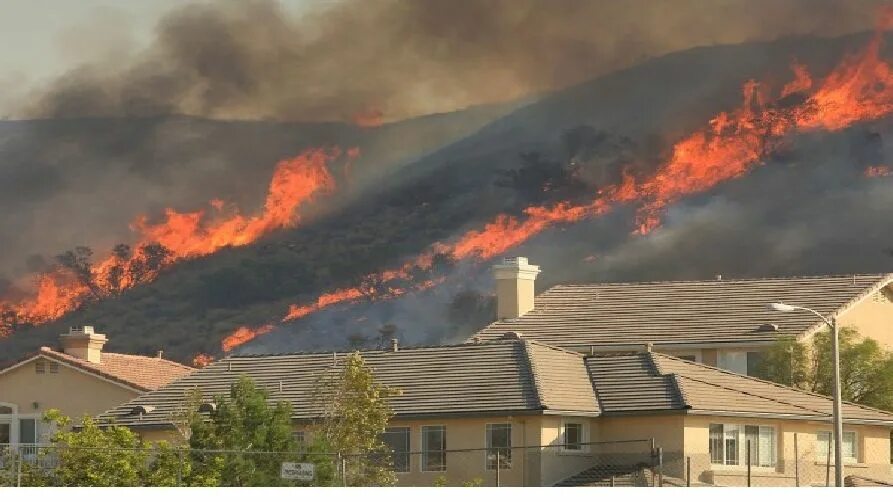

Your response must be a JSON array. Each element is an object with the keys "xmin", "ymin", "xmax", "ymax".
[{"xmin": 586, "ymin": 352, "xmax": 893, "ymax": 424}]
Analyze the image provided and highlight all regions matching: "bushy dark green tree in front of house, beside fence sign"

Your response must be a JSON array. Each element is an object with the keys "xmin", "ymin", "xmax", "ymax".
[{"xmin": 186, "ymin": 376, "xmax": 333, "ymax": 486}]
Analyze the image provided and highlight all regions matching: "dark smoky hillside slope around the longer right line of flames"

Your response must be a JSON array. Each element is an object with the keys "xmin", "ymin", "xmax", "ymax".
[{"xmin": 0, "ymin": 30, "xmax": 893, "ymax": 360}]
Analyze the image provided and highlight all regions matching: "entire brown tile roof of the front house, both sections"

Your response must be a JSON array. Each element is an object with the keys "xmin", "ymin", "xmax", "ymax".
[{"xmin": 100, "ymin": 340, "xmax": 893, "ymax": 427}]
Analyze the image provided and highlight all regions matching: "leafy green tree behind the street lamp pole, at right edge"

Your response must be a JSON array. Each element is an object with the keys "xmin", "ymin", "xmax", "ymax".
[{"xmin": 758, "ymin": 327, "xmax": 893, "ymax": 410}]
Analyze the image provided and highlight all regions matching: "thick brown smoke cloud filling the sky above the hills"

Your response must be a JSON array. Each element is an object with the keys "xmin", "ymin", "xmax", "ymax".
[{"xmin": 18, "ymin": 0, "xmax": 884, "ymax": 121}]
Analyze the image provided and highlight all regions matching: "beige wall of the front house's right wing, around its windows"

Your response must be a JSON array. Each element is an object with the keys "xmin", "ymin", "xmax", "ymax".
[{"xmin": 684, "ymin": 415, "xmax": 893, "ymax": 486}]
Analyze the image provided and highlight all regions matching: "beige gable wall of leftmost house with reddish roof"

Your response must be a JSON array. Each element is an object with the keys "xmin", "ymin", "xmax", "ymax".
[{"xmin": 0, "ymin": 358, "xmax": 139, "ymax": 434}]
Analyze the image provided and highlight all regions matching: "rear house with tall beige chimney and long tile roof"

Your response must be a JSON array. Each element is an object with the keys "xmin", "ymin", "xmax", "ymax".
[{"xmin": 474, "ymin": 257, "xmax": 893, "ymax": 375}]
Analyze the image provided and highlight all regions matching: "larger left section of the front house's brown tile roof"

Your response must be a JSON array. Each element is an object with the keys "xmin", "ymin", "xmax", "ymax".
[{"xmin": 101, "ymin": 340, "xmax": 598, "ymax": 426}]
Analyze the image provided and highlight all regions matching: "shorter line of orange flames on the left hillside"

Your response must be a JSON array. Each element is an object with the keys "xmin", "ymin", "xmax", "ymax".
[{"xmin": 0, "ymin": 148, "xmax": 348, "ymax": 335}]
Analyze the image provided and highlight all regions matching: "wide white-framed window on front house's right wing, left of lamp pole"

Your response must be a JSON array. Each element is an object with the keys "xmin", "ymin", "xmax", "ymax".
[{"xmin": 709, "ymin": 424, "xmax": 776, "ymax": 467}]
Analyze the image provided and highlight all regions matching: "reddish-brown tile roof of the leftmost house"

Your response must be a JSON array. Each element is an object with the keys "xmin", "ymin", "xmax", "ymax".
[{"xmin": 34, "ymin": 347, "xmax": 194, "ymax": 391}]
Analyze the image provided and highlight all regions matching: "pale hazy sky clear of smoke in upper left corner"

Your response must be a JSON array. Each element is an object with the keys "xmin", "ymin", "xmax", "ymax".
[{"xmin": 0, "ymin": 0, "xmax": 324, "ymax": 91}]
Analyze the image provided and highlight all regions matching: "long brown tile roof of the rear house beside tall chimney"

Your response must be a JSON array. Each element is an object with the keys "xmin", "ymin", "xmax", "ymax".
[{"xmin": 476, "ymin": 274, "xmax": 893, "ymax": 348}]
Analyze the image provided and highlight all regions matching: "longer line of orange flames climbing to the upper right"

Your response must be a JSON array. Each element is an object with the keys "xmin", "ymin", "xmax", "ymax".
[{"xmin": 221, "ymin": 15, "xmax": 893, "ymax": 352}]
